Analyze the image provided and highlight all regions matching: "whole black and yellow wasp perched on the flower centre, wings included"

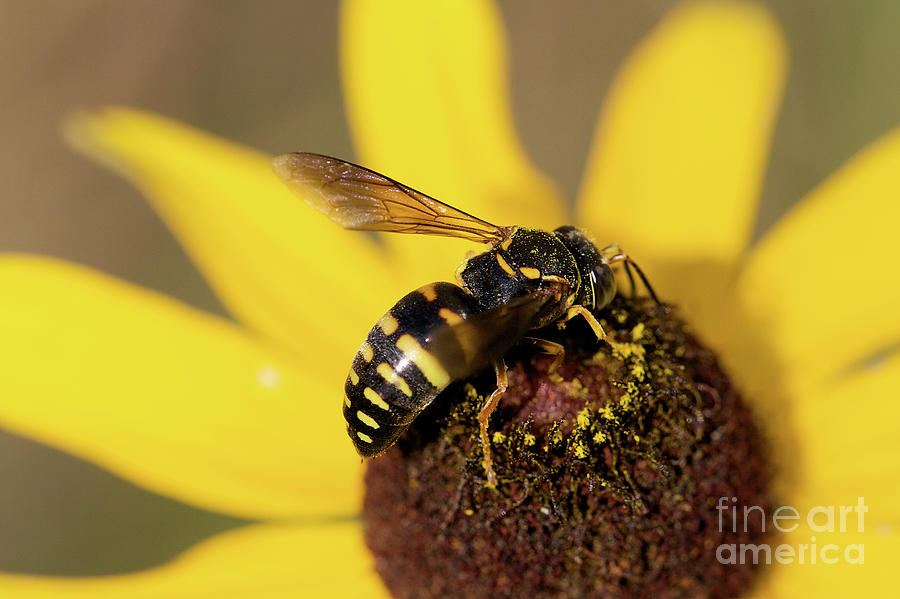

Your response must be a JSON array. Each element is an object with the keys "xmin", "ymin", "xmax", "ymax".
[{"xmin": 274, "ymin": 153, "xmax": 656, "ymax": 487}]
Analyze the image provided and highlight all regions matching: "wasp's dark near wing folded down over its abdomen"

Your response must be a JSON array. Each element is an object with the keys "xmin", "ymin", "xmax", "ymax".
[{"xmin": 429, "ymin": 289, "xmax": 555, "ymax": 379}]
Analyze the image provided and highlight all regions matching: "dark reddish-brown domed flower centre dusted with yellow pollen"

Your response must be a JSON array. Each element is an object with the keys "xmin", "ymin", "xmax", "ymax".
[{"xmin": 363, "ymin": 297, "xmax": 773, "ymax": 599}]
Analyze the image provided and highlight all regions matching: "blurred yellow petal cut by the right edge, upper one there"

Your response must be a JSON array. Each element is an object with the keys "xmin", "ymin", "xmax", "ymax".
[{"xmin": 734, "ymin": 129, "xmax": 900, "ymax": 391}]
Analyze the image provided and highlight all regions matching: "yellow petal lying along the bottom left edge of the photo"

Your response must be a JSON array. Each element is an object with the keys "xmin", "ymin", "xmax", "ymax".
[{"xmin": 0, "ymin": 522, "xmax": 389, "ymax": 599}]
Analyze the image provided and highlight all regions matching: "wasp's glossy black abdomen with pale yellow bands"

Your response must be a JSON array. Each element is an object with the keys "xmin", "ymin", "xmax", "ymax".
[{"xmin": 344, "ymin": 283, "xmax": 477, "ymax": 457}]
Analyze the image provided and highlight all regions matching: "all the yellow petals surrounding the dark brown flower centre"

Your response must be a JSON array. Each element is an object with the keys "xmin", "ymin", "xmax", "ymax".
[{"xmin": 0, "ymin": 1, "xmax": 900, "ymax": 598}]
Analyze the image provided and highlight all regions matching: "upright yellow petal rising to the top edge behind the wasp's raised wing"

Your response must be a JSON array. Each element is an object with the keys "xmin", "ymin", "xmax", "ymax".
[{"xmin": 341, "ymin": 0, "xmax": 566, "ymax": 286}]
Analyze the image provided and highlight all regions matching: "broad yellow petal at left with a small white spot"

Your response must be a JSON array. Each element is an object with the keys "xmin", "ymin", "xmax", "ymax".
[{"xmin": 0, "ymin": 257, "xmax": 361, "ymax": 518}]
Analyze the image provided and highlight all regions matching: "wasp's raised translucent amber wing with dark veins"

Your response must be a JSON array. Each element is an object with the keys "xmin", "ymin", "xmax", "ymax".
[{"xmin": 273, "ymin": 152, "xmax": 512, "ymax": 243}]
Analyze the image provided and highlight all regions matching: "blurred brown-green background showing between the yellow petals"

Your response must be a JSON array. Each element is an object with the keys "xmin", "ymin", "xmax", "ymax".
[{"xmin": 0, "ymin": 0, "xmax": 900, "ymax": 575}]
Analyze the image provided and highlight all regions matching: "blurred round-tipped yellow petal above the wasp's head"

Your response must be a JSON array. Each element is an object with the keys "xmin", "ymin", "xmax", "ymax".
[{"xmin": 579, "ymin": 2, "xmax": 786, "ymax": 317}]
